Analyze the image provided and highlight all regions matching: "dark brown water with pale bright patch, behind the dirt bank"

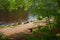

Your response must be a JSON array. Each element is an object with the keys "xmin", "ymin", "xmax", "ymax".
[{"xmin": 0, "ymin": 9, "xmax": 36, "ymax": 25}]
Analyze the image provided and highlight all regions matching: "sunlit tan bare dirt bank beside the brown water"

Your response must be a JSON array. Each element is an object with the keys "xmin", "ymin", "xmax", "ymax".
[{"xmin": 0, "ymin": 22, "xmax": 45, "ymax": 36}]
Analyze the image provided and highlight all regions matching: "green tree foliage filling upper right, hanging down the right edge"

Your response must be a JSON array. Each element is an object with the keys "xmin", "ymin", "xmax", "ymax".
[{"xmin": 30, "ymin": 0, "xmax": 60, "ymax": 27}]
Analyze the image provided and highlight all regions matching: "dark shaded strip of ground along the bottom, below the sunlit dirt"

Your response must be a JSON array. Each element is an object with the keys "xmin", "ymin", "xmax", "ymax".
[{"xmin": 7, "ymin": 32, "xmax": 60, "ymax": 40}]
